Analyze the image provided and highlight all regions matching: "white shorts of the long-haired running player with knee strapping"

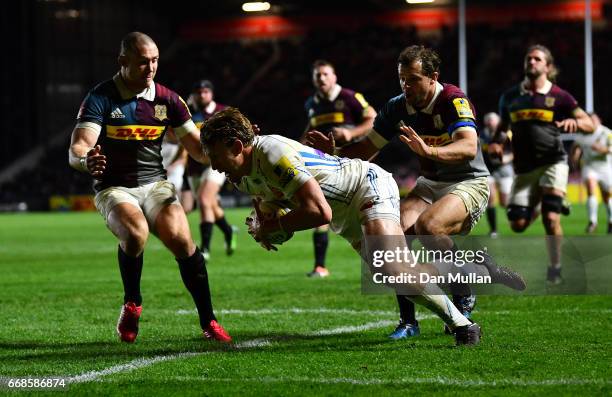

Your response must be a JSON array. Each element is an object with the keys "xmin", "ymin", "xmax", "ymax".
[{"xmin": 509, "ymin": 162, "xmax": 569, "ymax": 207}]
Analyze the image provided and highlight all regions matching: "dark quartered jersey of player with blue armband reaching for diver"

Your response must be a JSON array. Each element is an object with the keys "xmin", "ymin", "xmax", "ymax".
[{"xmin": 374, "ymin": 83, "xmax": 489, "ymax": 182}]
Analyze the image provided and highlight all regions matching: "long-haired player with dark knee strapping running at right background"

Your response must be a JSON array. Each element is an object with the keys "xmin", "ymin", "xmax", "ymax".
[{"xmin": 489, "ymin": 45, "xmax": 593, "ymax": 284}]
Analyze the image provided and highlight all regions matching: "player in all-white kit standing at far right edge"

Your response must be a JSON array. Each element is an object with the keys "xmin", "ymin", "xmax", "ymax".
[{"xmin": 572, "ymin": 113, "xmax": 612, "ymax": 234}]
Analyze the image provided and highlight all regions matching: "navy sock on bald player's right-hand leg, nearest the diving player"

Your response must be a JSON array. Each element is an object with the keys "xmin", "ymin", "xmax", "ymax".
[{"xmin": 176, "ymin": 248, "xmax": 216, "ymax": 329}]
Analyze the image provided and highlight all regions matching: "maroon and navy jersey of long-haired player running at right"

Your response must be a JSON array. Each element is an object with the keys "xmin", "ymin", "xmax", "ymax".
[{"xmin": 499, "ymin": 84, "xmax": 578, "ymax": 173}]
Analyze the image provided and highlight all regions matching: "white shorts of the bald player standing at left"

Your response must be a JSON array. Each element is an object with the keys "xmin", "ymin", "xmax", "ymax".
[{"xmin": 94, "ymin": 181, "xmax": 181, "ymax": 230}]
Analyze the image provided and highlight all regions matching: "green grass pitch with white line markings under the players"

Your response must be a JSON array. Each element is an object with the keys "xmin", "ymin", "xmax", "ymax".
[{"xmin": 0, "ymin": 206, "xmax": 612, "ymax": 396}]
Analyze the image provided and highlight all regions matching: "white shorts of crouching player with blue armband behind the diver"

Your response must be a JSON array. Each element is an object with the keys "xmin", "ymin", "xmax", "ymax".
[{"xmin": 410, "ymin": 176, "xmax": 490, "ymax": 234}]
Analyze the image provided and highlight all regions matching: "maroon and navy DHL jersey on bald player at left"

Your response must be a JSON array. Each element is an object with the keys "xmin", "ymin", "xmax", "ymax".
[{"xmin": 77, "ymin": 75, "xmax": 191, "ymax": 192}]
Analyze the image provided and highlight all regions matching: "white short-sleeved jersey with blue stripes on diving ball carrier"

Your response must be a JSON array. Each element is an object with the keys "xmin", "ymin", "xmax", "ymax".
[{"xmin": 236, "ymin": 135, "xmax": 367, "ymax": 208}]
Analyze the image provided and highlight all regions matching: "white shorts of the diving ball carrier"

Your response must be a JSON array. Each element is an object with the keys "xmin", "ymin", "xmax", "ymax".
[{"xmin": 328, "ymin": 164, "xmax": 400, "ymax": 245}]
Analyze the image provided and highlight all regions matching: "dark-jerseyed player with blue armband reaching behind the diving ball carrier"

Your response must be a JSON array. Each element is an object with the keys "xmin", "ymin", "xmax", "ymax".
[{"xmin": 309, "ymin": 46, "xmax": 492, "ymax": 339}]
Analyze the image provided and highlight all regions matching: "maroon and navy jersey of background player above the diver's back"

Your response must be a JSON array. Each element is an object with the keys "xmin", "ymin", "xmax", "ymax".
[{"xmin": 304, "ymin": 86, "xmax": 370, "ymax": 133}]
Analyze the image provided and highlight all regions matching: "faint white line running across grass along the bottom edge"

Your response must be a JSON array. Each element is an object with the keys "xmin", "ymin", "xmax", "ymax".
[{"xmin": 170, "ymin": 376, "xmax": 612, "ymax": 387}]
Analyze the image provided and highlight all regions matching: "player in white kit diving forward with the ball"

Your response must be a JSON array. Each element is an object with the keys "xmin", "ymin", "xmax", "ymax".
[{"xmin": 200, "ymin": 108, "xmax": 524, "ymax": 345}]
